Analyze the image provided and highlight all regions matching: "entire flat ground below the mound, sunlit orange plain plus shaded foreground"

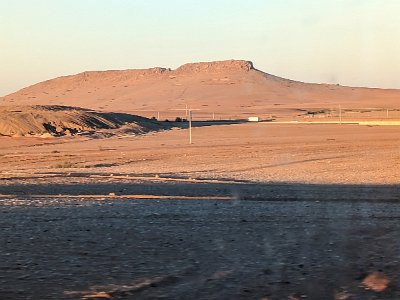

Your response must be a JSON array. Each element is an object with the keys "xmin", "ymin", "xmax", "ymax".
[{"xmin": 0, "ymin": 123, "xmax": 400, "ymax": 299}]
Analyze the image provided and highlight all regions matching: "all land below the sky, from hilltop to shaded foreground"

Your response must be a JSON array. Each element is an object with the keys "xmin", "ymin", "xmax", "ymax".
[{"xmin": 0, "ymin": 61, "xmax": 400, "ymax": 299}]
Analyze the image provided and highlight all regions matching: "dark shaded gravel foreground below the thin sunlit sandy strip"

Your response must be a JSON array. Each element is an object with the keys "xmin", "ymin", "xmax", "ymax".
[{"xmin": 0, "ymin": 191, "xmax": 400, "ymax": 300}]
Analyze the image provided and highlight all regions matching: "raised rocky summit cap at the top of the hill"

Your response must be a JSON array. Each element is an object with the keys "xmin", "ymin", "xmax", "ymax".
[{"xmin": 174, "ymin": 60, "xmax": 253, "ymax": 74}]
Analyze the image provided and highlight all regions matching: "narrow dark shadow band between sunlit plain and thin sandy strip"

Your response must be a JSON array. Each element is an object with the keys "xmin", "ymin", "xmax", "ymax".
[{"xmin": 0, "ymin": 178, "xmax": 400, "ymax": 202}]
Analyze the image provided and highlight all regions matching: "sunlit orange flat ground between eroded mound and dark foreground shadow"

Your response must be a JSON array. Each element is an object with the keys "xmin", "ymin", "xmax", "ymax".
[{"xmin": 0, "ymin": 123, "xmax": 400, "ymax": 184}]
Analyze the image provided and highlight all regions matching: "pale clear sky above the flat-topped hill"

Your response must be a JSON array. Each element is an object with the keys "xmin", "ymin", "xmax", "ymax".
[{"xmin": 0, "ymin": 0, "xmax": 400, "ymax": 96}]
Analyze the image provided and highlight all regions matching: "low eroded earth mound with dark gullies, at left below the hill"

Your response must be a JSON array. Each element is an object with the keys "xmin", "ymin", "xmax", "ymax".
[{"xmin": 0, "ymin": 105, "xmax": 161, "ymax": 137}]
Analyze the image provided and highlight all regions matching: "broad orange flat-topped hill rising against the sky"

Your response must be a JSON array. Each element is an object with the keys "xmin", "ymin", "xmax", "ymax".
[{"xmin": 0, "ymin": 60, "xmax": 400, "ymax": 118}]
